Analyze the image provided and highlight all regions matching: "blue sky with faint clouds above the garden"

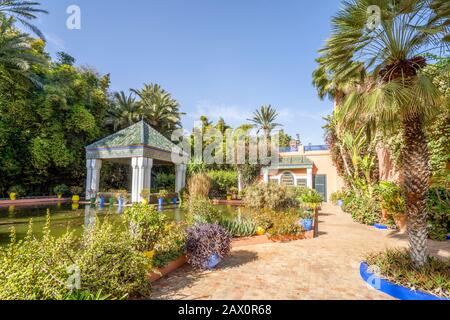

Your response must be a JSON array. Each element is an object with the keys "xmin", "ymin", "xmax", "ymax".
[{"xmin": 38, "ymin": 0, "xmax": 340, "ymax": 144}]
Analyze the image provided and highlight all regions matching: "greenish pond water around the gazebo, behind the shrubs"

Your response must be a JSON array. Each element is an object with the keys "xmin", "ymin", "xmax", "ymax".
[{"xmin": 0, "ymin": 204, "xmax": 240, "ymax": 246}]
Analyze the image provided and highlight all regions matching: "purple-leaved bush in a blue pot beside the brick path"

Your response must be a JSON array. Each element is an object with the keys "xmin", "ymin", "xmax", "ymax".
[{"xmin": 186, "ymin": 224, "xmax": 231, "ymax": 270}]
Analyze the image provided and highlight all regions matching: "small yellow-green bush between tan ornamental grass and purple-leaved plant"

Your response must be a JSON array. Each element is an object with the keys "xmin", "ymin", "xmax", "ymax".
[{"xmin": 183, "ymin": 197, "xmax": 222, "ymax": 224}]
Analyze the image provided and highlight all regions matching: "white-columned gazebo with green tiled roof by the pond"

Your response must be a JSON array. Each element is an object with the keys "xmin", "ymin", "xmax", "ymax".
[{"xmin": 86, "ymin": 121, "xmax": 186, "ymax": 203}]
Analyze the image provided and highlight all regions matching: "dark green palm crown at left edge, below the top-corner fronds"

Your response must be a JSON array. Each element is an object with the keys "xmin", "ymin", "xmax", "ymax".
[{"xmin": 0, "ymin": 17, "xmax": 46, "ymax": 84}]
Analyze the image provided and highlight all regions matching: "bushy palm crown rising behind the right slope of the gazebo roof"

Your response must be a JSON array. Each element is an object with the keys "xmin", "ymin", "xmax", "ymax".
[{"xmin": 131, "ymin": 83, "xmax": 184, "ymax": 136}]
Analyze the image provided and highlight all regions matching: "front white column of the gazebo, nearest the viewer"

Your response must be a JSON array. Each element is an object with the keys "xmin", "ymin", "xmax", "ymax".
[{"xmin": 131, "ymin": 157, "xmax": 153, "ymax": 203}]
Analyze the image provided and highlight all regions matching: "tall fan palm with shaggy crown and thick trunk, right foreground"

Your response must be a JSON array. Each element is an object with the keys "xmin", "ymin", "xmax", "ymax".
[{"xmin": 320, "ymin": 0, "xmax": 449, "ymax": 267}]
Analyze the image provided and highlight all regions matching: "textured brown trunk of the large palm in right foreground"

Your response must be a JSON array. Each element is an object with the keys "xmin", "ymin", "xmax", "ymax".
[{"xmin": 402, "ymin": 117, "xmax": 431, "ymax": 267}]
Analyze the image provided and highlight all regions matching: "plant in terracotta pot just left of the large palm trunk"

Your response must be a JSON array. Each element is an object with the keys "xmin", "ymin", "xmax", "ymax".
[{"xmin": 377, "ymin": 181, "xmax": 408, "ymax": 233}]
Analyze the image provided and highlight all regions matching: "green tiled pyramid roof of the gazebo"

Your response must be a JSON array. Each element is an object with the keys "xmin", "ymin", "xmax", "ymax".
[{"xmin": 87, "ymin": 121, "xmax": 175, "ymax": 152}]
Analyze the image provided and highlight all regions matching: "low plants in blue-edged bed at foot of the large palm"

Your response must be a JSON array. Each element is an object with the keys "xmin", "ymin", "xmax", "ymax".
[{"xmin": 366, "ymin": 249, "xmax": 450, "ymax": 298}]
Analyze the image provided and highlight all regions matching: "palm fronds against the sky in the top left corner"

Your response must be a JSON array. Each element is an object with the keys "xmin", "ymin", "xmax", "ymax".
[{"xmin": 0, "ymin": 0, "xmax": 48, "ymax": 39}]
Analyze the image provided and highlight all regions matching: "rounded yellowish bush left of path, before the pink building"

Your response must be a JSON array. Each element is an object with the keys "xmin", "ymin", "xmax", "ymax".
[{"xmin": 244, "ymin": 183, "xmax": 297, "ymax": 210}]
